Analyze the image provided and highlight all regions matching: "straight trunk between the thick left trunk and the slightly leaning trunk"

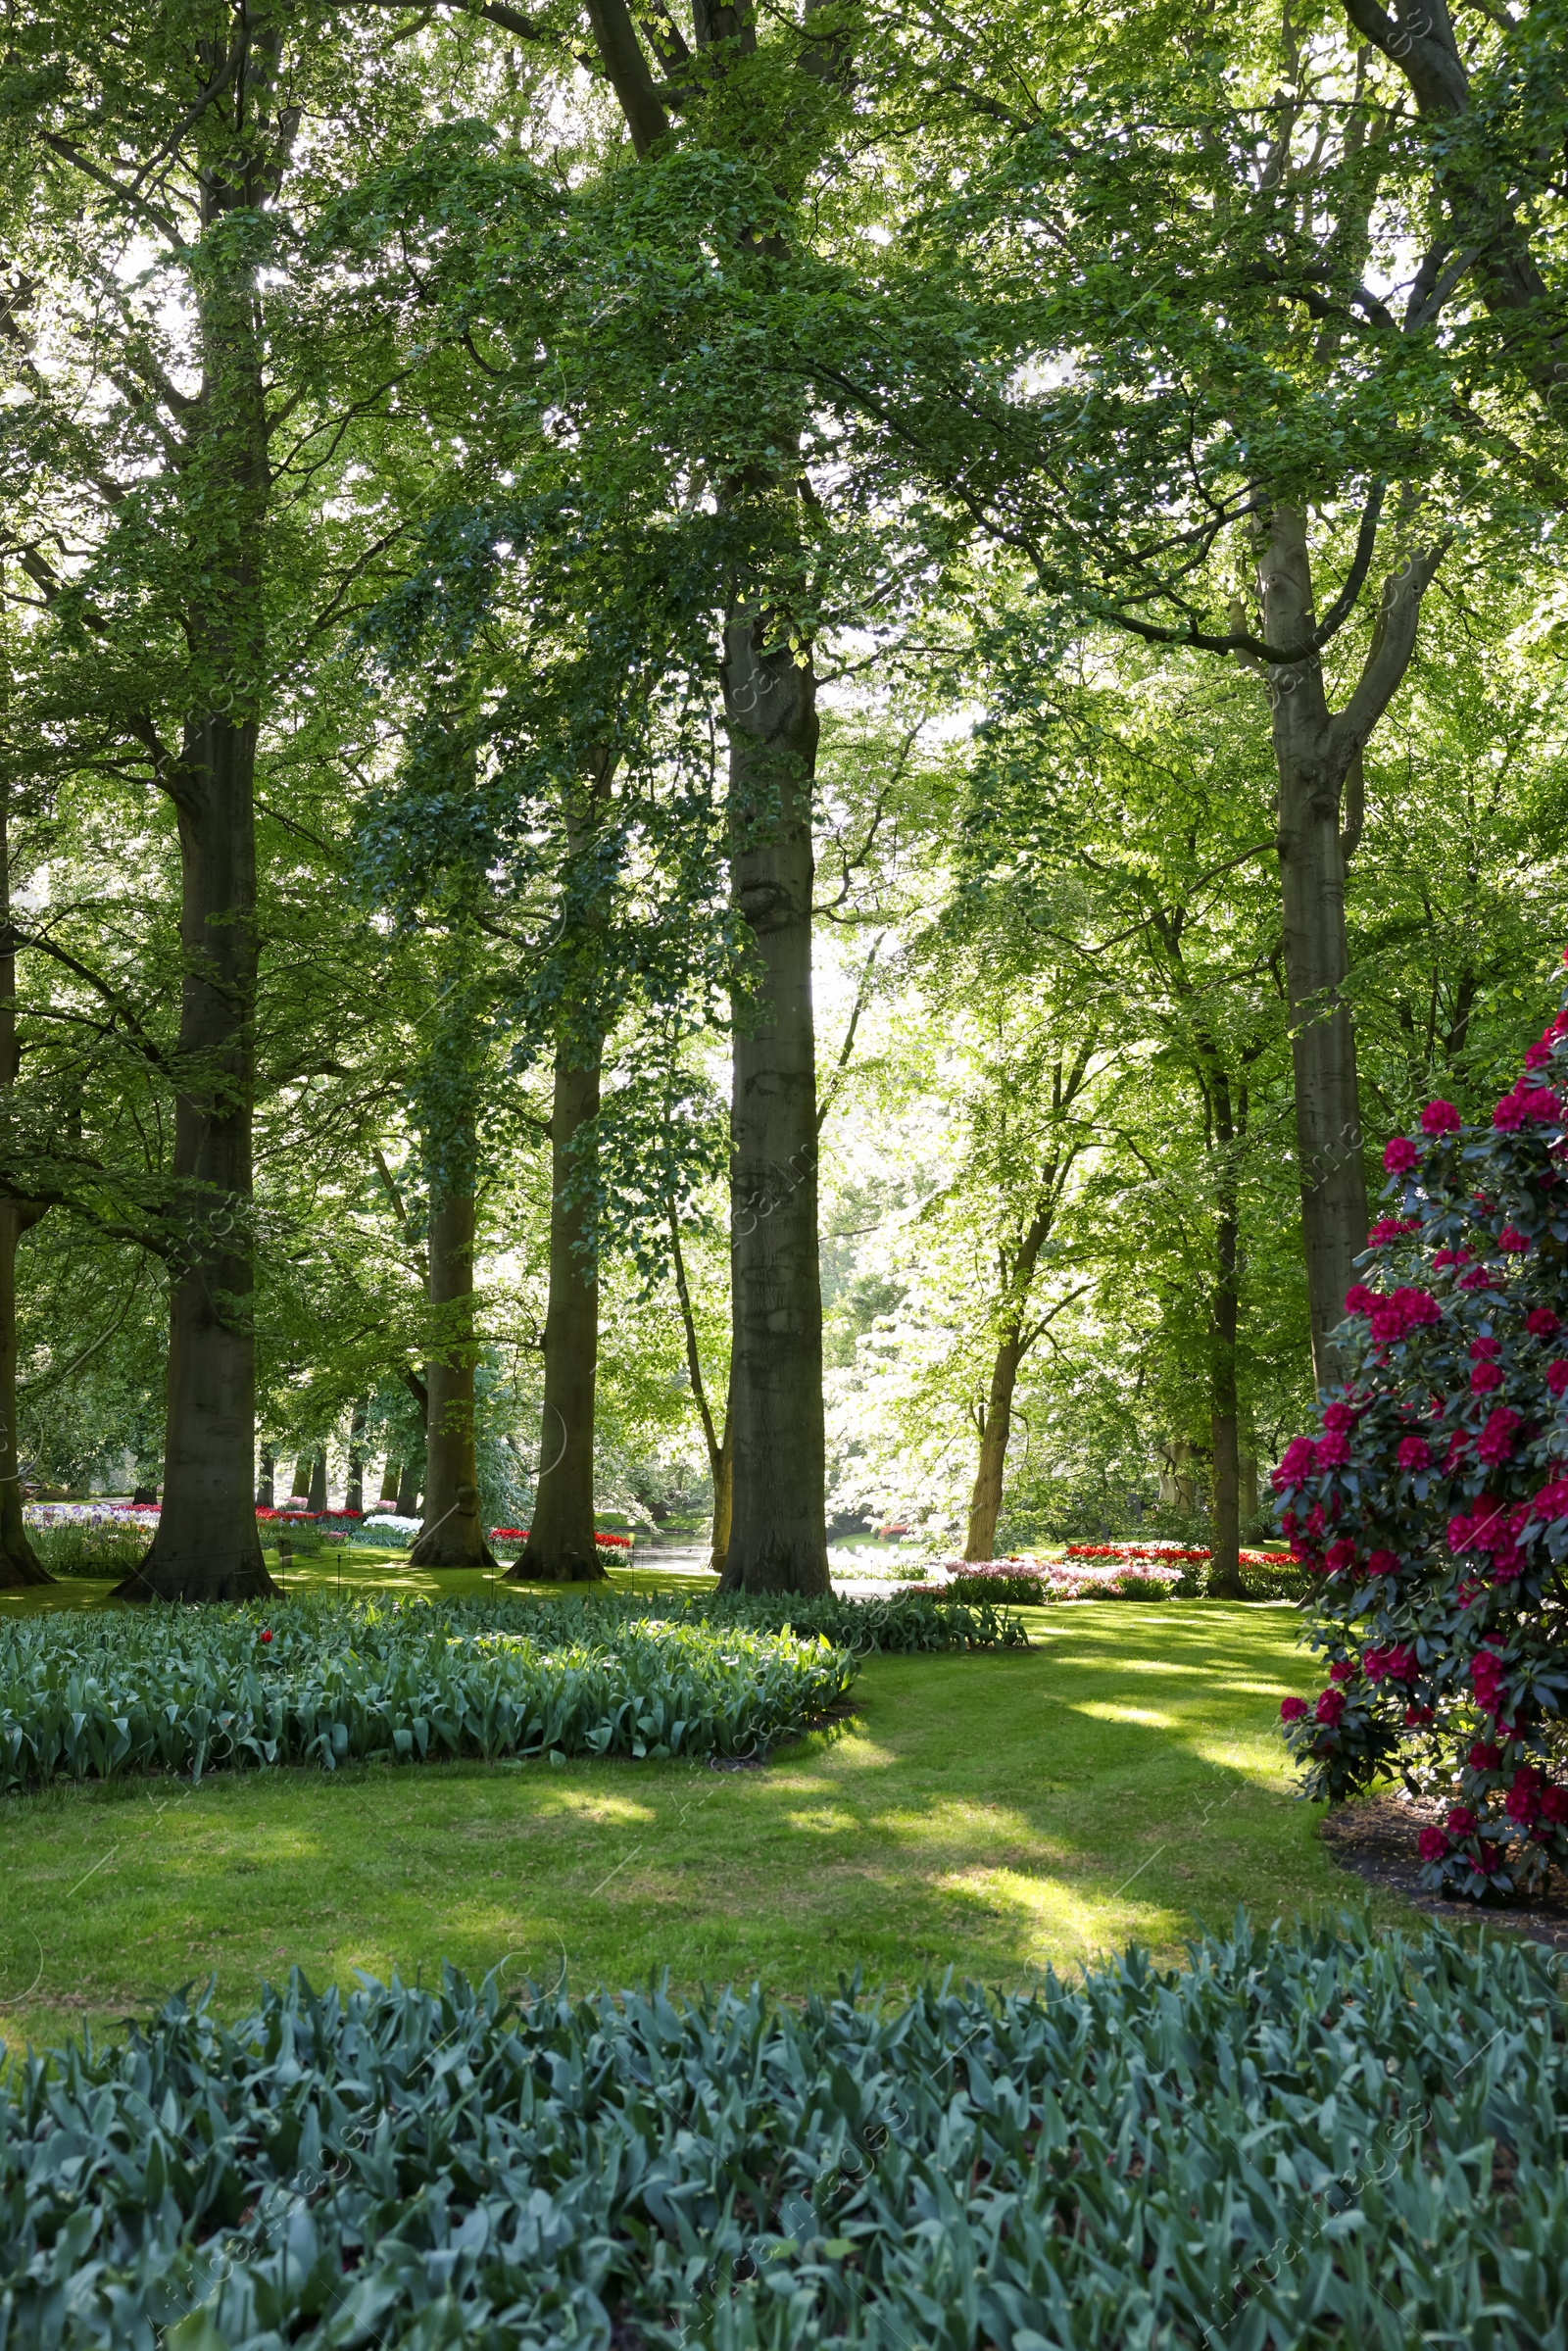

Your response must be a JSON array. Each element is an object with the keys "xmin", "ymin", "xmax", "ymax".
[{"xmin": 409, "ymin": 1203, "xmax": 496, "ymax": 1568}]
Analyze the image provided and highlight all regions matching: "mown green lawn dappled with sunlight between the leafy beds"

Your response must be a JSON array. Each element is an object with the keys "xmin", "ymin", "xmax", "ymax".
[{"xmin": 0, "ymin": 1568, "xmax": 1398, "ymax": 2048}]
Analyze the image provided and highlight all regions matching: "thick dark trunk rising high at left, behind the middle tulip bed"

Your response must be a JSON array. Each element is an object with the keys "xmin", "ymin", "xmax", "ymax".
[{"xmin": 118, "ymin": 137, "xmax": 277, "ymax": 1601}]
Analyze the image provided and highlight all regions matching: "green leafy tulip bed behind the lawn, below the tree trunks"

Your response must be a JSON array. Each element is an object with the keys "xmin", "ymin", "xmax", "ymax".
[{"xmin": 0, "ymin": 1598, "xmax": 856, "ymax": 1795}]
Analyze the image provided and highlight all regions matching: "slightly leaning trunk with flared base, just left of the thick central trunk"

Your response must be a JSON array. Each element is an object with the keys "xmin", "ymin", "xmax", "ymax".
[{"xmin": 521, "ymin": 1044, "xmax": 604, "ymax": 1585}]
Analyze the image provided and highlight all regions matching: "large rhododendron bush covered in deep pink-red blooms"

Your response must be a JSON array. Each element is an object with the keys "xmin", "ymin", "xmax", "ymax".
[{"xmin": 1274, "ymin": 963, "xmax": 1568, "ymax": 1897}]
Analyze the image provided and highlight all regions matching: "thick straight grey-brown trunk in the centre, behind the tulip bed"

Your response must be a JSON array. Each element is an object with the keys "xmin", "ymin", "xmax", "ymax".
[{"xmin": 724, "ymin": 607, "xmax": 832, "ymax": 1592}]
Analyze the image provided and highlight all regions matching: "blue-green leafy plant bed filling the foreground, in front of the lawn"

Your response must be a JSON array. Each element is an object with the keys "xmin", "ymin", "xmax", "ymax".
[{"xmin": 0, "ymin": 1921, "xmax": 1568, "ymax": 2351}]
